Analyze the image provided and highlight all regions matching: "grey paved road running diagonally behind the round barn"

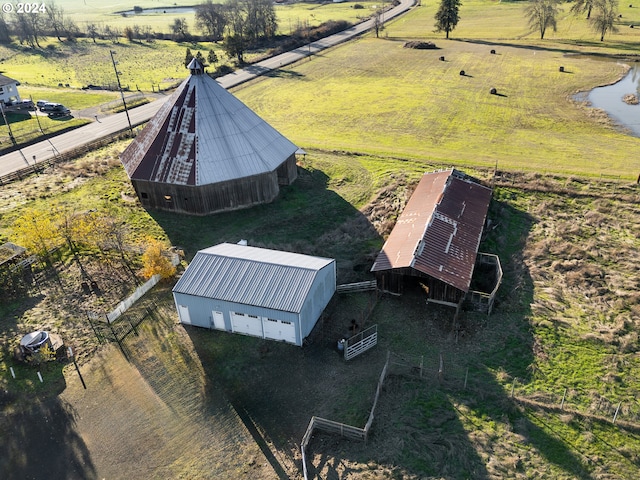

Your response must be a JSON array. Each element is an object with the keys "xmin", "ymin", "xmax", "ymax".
[{"xmin": 0, "ymin": 0, "xmax": 414, "ymax": 176}]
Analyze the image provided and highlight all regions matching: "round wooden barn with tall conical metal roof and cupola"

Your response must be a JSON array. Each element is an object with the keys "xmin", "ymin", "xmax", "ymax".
[{"xmin": 121, "ymin": 59, "xmax": 298, "ymax": 215}]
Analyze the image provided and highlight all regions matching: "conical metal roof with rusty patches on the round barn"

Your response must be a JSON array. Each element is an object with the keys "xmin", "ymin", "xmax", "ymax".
[{"xmin": 120, "ymin": 65, "xmax": 298, "ymax": 185}]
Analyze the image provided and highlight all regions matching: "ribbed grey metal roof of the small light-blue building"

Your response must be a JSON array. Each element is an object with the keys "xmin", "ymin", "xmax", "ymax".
[{"xmin": 173, "ymin": 243, "xmax": 335, "ymax": 313}]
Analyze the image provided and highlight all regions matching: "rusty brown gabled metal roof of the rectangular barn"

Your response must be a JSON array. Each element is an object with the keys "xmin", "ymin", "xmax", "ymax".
[{"xmin": 371, "ymin": 169, "xmax": 491, "ymax": 292}]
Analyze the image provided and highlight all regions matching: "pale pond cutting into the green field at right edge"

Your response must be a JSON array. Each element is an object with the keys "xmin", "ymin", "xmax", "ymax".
[{"xmin": 580, "ymin": 65, "xmax": 640, "ymax": 137}]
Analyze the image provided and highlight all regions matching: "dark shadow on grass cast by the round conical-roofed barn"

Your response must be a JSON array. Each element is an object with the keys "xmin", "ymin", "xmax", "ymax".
[{"xmin": 149, "ymin": 167, "xmax": 381, "ymax": 283}]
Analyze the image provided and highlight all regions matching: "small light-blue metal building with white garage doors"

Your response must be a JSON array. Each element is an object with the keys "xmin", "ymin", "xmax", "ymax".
[{"xmin": 173, "ymin": 243, "xmax": 336, "ymax": 346}]
